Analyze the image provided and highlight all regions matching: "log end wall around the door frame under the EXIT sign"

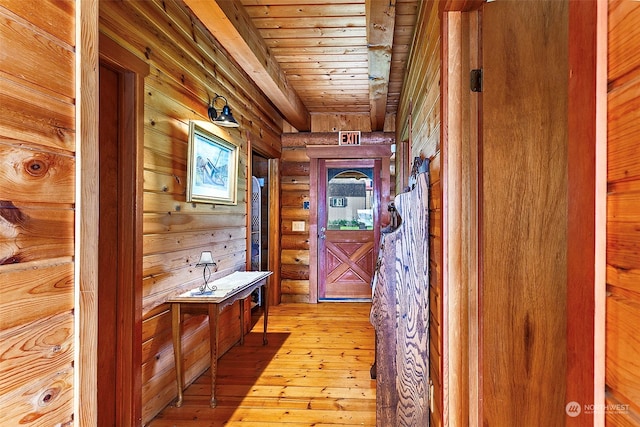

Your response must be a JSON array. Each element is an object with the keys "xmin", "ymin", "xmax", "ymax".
[{"xmin": 280, "ymin": 132, "xmax": 395, "ymax": 302}]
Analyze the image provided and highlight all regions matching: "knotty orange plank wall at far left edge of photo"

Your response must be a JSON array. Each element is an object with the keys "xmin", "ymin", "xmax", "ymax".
[{"xmin": 0, "ymin": 1, "xmax": 76, "ymax": 426}]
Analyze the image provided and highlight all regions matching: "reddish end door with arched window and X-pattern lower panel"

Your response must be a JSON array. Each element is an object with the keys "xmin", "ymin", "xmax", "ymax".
[{"xmin": 318, "ymin": 159, "xmax": 380, "ymax": 301}]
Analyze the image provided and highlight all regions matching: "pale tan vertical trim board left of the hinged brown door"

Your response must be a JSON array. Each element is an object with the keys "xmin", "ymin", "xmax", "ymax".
[{"xmin": 440, "ymin": 12, "xmax": 469, "ymax": 425}]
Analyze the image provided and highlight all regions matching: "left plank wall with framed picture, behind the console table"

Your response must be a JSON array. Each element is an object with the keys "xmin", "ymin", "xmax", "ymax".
[{"xmin": 100, "ymin": 0, "xmax": 282, "ymax": 423}]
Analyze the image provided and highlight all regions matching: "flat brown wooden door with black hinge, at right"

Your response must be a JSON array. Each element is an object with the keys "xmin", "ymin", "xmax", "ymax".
[{"xmin": 479, "ymin": 0, "xmax": 569, "ymax": 426}]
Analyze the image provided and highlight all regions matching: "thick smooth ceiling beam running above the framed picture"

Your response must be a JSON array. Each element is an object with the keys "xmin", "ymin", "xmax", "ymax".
[{"xmin": 184, "ymin": 0, "xmax": 311, "ymax": 131}]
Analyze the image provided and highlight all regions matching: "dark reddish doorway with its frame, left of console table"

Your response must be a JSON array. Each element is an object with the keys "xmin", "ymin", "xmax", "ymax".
[{"xmin": 97, "ymin": 34, "xmax": 149, "ymax": 426}]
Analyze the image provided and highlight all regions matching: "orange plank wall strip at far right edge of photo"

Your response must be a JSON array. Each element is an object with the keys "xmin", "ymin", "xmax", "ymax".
[{"xmin": 605, "ymin": 1, "xmax": 640, "ymax": 426}]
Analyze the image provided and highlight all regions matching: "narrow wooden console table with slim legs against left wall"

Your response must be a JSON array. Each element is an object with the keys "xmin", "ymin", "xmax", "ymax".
[{"xmin": 167, "ymin": 271, "xmax": 272, "ymax": 408}]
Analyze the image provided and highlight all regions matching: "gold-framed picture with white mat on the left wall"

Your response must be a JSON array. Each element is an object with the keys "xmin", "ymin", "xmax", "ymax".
[{"xmin": 187, "ymin": 121, "xmax": 238, "ymax": 205}]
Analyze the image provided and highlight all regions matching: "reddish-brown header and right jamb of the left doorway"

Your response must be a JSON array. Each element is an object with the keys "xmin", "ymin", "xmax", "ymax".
[{"xmin": 98, "ymin": 33, "xmax": 149, "ymax": 426}]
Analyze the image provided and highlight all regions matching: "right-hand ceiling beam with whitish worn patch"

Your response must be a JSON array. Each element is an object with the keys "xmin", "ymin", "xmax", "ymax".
[{"xmin": 365, "ymin": 0, "xmax": 396, "ymax": 131}]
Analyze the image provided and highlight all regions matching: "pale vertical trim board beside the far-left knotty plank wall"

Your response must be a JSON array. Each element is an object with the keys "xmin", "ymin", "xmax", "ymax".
[{"xmin": 74, "ymin": 2, "xmax": 99, "ymax": 426}]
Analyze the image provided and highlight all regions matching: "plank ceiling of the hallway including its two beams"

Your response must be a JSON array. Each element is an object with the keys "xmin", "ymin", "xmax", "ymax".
[{"xmin": 184, "ymin": 0, "xmax": 420, "ymax": 131}]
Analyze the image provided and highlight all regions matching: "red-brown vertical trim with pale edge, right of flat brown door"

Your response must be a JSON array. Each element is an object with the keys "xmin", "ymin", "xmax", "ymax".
[{"xmin": 565, "ymin": 1, "xmax": 608, "ymax": 426}]
